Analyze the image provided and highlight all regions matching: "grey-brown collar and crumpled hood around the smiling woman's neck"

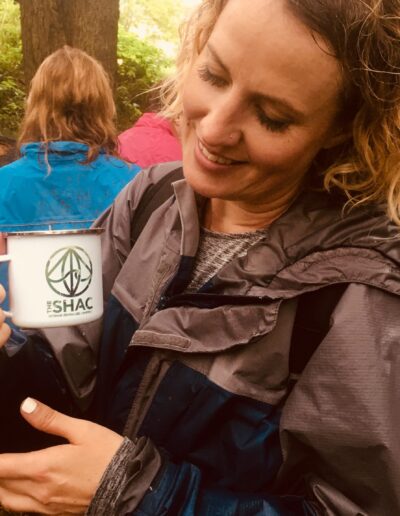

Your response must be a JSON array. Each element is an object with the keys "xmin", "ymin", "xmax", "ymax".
[{"xmin": 170, "ymin": 180, "xmax": 400, "ymax": 298}]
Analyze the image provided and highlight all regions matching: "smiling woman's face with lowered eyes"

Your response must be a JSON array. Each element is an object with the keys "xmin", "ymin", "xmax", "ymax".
[{"xmin": 181, "ymin": 0, "xmax": 341, "ymax": 211}]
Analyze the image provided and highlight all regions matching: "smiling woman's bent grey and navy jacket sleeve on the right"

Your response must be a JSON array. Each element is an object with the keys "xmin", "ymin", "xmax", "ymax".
[{"xmin": 90, "ymin": 284, "xmax": 400, "ymax": 516}]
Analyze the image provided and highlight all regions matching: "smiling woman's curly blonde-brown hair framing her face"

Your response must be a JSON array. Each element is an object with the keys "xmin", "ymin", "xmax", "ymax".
[{"xmin": 162, "ymin": 0, "xmax": 400, "ymax": 225}]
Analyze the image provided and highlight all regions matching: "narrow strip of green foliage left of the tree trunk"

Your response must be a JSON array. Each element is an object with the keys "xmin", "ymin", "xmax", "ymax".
[{"xmin": 0, "ymin": 0, "xmax": 25, "ymax": 136}]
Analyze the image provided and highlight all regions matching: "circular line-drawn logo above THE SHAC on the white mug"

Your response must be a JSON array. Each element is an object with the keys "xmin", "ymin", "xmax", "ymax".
[{"xmin": 46, "ymin": 247, "xmax": 93, "ymax": 297}]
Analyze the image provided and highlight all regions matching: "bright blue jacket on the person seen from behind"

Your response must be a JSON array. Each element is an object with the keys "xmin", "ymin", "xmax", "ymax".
[{"xmin": 0, "ymin": 141, "xmax": 140, "ymax": 308}]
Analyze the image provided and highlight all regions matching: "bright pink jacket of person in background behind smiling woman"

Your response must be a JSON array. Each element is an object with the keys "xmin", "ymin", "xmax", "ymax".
[{"xmin": 118, "ymin": 113, "xmax": 182, "ymax": 168}]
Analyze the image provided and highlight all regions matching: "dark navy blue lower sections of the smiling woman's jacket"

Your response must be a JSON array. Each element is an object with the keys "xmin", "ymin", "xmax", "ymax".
[{"xmin": 97, "ymin": 297, "xmax": 311, "ymax": 515}]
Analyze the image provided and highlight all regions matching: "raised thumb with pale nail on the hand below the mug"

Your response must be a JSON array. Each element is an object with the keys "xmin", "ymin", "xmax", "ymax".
[{"xmin": 21, "ymin": 398, "xmax": 84, "ymax": 444}]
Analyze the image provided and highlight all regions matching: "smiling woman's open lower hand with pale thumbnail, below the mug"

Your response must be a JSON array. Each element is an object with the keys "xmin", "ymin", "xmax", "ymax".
[{"xmin": 0, "ymin": 398, "xmax": 123, "ymax": 515}]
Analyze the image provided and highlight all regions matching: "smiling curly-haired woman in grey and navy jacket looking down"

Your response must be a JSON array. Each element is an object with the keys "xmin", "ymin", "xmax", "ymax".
[{"xmin": 0, "ymin": 0, "xmax": 400, "ymax": 516}]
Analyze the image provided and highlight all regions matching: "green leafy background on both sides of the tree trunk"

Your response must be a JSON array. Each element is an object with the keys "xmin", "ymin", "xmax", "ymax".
[{"xmin": 0, "ymin": 0, "xmax": 190, "ymax": 137}]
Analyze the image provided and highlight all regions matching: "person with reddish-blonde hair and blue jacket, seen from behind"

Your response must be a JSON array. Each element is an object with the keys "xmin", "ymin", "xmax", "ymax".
[{"xmin": 0, "ymin": 46, "xmax": 139, "ymax": 232}]
